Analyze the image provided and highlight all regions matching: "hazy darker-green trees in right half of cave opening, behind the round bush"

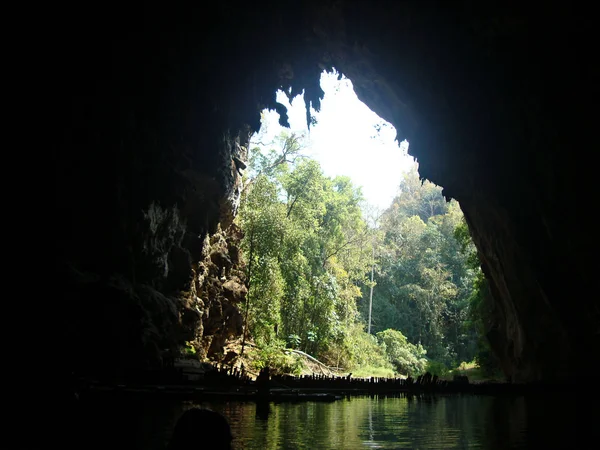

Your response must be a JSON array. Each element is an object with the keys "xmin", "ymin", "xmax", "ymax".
[{"xmin": 361, "ymin": 168, "xmax": 477, "ymax": 366}]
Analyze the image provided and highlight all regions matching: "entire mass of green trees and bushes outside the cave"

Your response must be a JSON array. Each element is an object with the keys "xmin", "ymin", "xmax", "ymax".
[{"xmin": 236, "ymin": 134, "xmax": 488, "ymax": 375}]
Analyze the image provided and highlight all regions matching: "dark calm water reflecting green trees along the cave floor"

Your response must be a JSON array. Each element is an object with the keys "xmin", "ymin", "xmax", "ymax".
[{"xmin": 71, "ymin": 395, "xmax": 598, "ymax": 450}]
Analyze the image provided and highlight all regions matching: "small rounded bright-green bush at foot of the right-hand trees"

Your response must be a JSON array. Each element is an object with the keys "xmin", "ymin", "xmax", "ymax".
[{"xmin": 377, "ymin": 329, "xmax": 427, "ymax": 376}]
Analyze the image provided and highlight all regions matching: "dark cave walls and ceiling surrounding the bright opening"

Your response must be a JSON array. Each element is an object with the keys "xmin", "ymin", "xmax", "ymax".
[{"xmin": 51, "ymin": 0, "xmax": 600, "ymax": 390}]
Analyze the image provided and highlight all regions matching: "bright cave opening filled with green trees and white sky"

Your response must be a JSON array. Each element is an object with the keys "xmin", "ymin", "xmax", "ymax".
[{"xmin": 237, "ymin": 71, "xmax": 488, "ymax": 376}]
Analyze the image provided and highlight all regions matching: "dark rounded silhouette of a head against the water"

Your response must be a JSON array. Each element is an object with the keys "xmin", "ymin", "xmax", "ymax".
[{"xmin": 169, "ymin": 408, "xmax": 233, "ymax": 450}]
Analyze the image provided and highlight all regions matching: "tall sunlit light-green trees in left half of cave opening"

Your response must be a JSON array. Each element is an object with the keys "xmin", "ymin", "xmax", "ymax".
[{"xmin": 237, "ymin": 131, "xmax": 370, "ymax": 355}]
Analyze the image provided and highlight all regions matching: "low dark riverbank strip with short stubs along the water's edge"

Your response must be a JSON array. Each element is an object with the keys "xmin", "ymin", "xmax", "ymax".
[{"xmin": 77, "ymin": 371, "xmax": 573, "ymax": 402}]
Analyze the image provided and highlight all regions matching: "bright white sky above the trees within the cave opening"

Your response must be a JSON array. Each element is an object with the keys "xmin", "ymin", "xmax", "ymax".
[{"xmin": 253, "ymin": 72, "xmax": 415, "ymax": 210}]
